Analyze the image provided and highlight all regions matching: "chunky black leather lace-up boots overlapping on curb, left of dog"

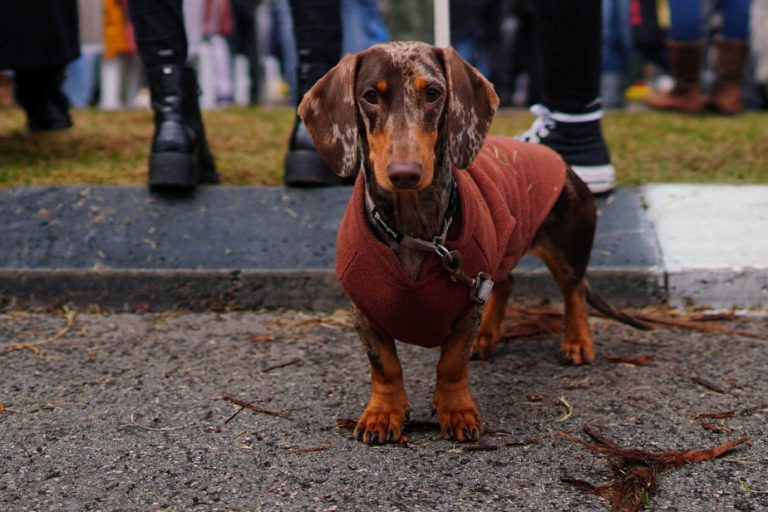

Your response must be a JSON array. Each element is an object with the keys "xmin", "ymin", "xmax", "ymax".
[{"xmin": 147, "ymin": 64, "xmax": 219, "ymax": 190}]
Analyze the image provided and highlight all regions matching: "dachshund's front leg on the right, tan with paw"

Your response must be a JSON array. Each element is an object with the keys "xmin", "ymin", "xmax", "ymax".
[{"xmin": 432, "ymin": 308, "xmax": 483, "ymax": 441}]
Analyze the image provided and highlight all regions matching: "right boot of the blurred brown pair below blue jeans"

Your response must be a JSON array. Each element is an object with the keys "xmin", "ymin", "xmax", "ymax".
[{"xmin": 709, "ymin": 39, "xmax": 749, "ymax": 115}]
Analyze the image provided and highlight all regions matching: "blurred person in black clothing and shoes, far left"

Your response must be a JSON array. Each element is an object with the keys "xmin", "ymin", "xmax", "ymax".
[{"xmin": 0, "ymin": 0, "xmax": 80, "ymax": 132}]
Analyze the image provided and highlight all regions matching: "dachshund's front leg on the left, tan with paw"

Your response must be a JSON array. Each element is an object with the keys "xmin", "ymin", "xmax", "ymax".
[{"xmin": 353, "ymin": 308, "xmax": 409, "ymax": 444}]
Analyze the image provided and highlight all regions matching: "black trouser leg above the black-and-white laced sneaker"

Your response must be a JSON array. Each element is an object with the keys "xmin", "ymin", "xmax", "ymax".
[{"xmin": 533, "ymin": 0, "xmax": 602, "ymax": 114}]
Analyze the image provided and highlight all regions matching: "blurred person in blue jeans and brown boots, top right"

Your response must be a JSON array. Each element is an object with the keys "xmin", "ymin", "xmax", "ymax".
[{"xmin": 646, "ymin": 0, "xmax": 749, "ymax": 115}]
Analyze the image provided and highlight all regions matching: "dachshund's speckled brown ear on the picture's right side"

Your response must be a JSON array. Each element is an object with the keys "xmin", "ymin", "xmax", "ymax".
[{"xmin": 435, "ymin": 48, "xmax": 499, "ymax": 169}]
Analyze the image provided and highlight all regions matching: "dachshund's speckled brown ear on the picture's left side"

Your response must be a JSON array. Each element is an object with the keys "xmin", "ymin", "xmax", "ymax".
[{"xmin": 299, "ymin": 54, "xmax": 360, "ymax": 177}]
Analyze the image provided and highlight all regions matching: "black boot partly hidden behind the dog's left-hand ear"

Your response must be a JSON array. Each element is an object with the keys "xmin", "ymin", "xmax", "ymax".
[{"xmin": 284, "ymin": 63, "xmax": 342, "ymax": 187}]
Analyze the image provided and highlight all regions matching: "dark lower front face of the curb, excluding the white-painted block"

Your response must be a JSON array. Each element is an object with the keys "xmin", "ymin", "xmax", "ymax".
[{"xmin": 0, "ymin": 268, "xmax": 666, "ymax": 312}]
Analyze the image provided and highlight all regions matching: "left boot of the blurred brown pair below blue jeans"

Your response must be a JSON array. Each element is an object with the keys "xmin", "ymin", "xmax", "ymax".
[{"xmin": 645, "ymin": 41, "xmax": 705, "ymax": 113}]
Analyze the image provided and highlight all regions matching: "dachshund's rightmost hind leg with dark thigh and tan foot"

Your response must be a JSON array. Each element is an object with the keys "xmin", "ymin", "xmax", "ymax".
[{"xmin": 530, "ymin": 170, "xmax": 597, "ymax": 365}]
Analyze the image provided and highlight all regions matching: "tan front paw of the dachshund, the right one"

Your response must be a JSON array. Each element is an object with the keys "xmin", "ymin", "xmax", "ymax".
[{"xmin": 432, "ymin": 389, "xmax": 483, "ymax": 442}]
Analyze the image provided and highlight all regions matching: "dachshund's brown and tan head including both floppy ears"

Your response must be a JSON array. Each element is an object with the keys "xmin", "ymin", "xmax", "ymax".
[{"xmin": 299, "ymin": 42, "xmax": 499, "ymax": 191}]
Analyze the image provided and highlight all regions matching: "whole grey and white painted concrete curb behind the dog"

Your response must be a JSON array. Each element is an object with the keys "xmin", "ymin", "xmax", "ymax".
[{"xmin": 0, "ymin": 185, "xmax": 768, "ymax": 311}]
